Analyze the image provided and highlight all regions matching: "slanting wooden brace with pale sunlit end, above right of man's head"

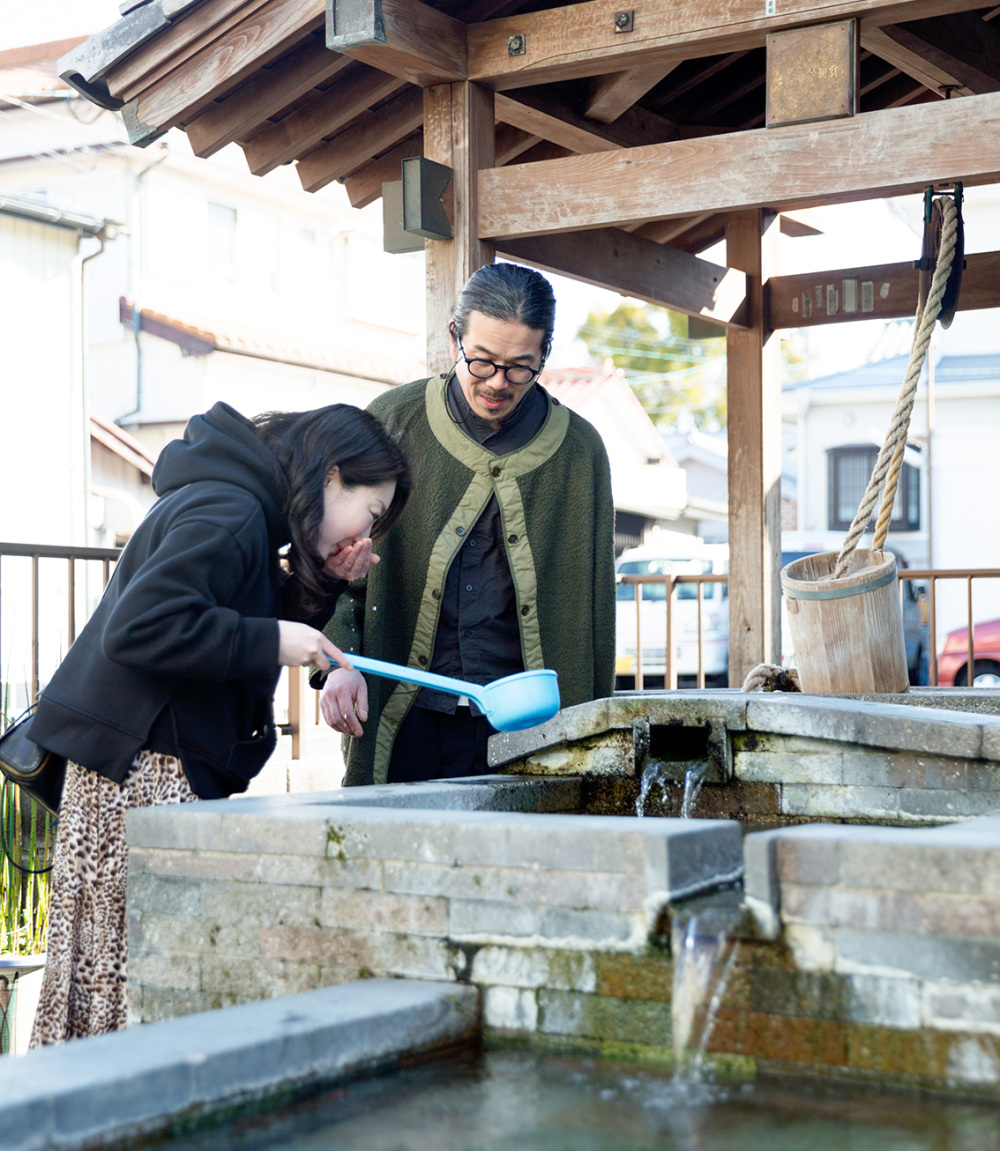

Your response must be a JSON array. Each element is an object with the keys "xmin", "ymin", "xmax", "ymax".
[{"xmin": 497, "ymin": 228, "xmax": 747, "ymax": 327}]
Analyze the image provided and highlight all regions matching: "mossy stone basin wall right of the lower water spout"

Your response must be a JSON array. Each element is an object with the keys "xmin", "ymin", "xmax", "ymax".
[{"xmin": 731, "ymin": 816, "xmax": 1000, "ymax": 1095}]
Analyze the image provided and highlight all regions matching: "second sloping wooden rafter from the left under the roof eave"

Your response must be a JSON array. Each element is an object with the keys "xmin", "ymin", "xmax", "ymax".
[{"xmin": 184, "ymin": 39, "xmax": 351, "ymax": 158}]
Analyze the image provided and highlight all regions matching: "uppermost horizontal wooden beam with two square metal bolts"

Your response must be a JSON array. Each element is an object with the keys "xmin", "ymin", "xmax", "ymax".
[{"xmin": 468, "ymin": 0, "xmax": 975, "ymax": 91}]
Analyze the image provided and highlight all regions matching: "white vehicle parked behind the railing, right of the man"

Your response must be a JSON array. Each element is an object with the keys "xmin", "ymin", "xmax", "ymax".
[{"xmin": 614, "ymin": 531, "xmax": 730, "ymax": 689}]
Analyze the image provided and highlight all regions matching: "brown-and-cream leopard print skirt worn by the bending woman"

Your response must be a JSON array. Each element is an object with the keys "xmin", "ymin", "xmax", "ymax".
[{"xmin": 30, "ymin": 750, "xmax": 198, "ymax": 1047}]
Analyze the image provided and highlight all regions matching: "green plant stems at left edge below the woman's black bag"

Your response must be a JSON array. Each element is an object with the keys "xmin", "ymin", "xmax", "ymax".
[{"xmin": 0, "ymin": 686, "xmax": 55, "ymax": 955}]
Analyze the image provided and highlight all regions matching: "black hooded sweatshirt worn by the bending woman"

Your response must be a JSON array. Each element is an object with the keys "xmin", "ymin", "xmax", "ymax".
[{"xmin": 31, "ymin": 403, "xmax": 319, "ymax": 799}]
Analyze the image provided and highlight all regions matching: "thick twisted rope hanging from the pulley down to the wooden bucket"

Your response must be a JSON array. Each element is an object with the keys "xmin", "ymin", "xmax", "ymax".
[{"xmin": 833, "ymin": 196, "xmax": 959, "ymax": 579}]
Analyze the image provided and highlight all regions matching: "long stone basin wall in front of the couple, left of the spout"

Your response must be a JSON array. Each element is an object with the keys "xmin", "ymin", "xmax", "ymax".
[{"xmin": 128, "ymin": 779, "xmax": 742, "ymax": 1049}]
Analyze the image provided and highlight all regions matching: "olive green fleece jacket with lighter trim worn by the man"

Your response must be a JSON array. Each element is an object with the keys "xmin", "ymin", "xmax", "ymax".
[{"xmin": 326, "ymin": 376, "xmax": 614, "ymax": 786}]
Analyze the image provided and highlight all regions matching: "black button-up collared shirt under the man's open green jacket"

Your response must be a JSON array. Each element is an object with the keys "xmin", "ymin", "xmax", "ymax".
[{"xmin": 417, "ymin": 373, "xmax": 549, "ymax": 712}]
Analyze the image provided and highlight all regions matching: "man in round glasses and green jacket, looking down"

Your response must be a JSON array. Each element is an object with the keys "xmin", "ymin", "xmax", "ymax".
[{"xmin": 320, "ymin": 264, "xmax": 614, "ymax": 786}]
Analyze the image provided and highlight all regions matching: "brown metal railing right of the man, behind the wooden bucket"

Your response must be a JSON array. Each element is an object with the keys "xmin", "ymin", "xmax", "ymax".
[{"xmin": 618, "ymin": 567, "xmax": 1000, "ymax": 691}]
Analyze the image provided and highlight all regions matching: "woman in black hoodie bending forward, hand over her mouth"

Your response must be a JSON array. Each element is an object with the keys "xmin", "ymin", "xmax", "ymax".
[{"xmin": 31, "ymin": 404, "xmax": 410, "ymax": 1046}]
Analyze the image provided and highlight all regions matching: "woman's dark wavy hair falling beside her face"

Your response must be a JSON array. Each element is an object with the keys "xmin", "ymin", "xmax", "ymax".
[{"xmin": 251, "ymin": 404, "xmax": 412, "ymax": 615}]
